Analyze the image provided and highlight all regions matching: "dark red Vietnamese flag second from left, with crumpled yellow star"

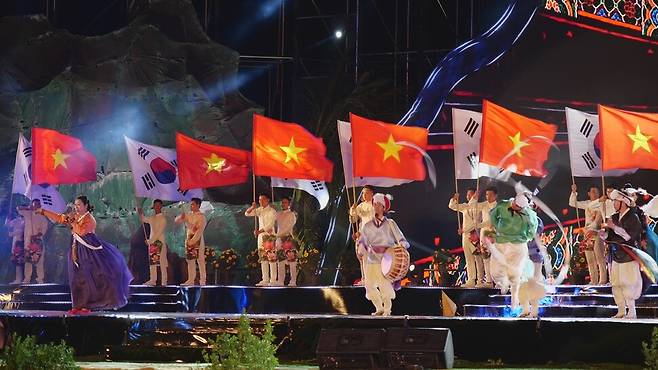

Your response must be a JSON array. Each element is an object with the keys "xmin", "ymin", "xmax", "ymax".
[{"xmin": 176, "ymin": 132, "xmax": 251, "ymax": 190}]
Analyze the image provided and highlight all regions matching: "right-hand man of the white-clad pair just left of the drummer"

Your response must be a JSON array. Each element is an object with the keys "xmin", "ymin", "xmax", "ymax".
[{"xmin": 276, "ymin": 197, "xmax": 297, "ymax": 286}]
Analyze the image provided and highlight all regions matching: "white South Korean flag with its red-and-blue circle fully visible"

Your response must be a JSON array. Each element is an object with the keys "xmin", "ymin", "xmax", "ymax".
[{"xmin": 124, "ymin": 136, "xmax": 203, "ymax": 201}]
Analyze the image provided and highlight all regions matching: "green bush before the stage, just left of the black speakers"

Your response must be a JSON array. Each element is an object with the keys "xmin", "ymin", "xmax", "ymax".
[{"xmin": 203, "ymin": 314, "xmax": 279, "ymax": 369}]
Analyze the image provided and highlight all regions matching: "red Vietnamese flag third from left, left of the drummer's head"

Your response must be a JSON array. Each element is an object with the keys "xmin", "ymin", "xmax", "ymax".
[{"xmin": 253, "ymin": 114, "xmax": 334, "ymax": 181}]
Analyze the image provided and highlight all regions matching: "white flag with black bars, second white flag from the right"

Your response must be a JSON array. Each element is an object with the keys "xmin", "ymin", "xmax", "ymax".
[{"xmin": 452, "ymin": 108, "xmax": 500, "ymax": 179}]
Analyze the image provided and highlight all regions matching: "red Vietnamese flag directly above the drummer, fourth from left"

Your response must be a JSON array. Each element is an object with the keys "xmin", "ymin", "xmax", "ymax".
[{"xmin": 347, "ymin": 113, "xmax": 428, "ymax": 181}]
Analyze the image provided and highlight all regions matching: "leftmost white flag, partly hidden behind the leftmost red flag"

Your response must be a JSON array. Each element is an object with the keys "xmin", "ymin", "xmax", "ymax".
[{"xmin": 11, "ymin": 134, "xmax": 66, "ymax": 213}]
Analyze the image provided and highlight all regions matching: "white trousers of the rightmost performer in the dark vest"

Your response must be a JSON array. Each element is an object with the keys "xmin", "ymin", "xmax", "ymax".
[{"xmin": 610, "ymin": 261, "xmax": 642, "ymax": 318}]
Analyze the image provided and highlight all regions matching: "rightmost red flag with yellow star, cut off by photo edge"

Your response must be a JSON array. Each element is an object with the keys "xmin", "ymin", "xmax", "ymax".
[{"xmin": 599, "ymin": 105, "xmax": 658, "ymax": 171}]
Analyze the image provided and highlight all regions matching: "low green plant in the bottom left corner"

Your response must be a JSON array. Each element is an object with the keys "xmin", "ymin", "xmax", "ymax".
[{"xmin": 0, "ymin": 336, "xmax": 79, "ymax": 370}]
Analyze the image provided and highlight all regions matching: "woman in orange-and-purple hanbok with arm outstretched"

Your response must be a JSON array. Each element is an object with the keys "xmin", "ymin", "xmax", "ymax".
[{"xmin": 38, "ymin": 195, "xmax": 133, "ymax": 314}]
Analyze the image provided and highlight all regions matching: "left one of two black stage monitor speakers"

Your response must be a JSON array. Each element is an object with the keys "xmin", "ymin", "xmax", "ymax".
[{"xmin": 316, "ymin": 329, "xmax": 386, "ymax": 369}]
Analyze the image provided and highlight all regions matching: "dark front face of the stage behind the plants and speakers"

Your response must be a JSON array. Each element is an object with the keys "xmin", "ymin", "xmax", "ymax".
[{"xmin": 0, "ymin": 315, "xmax": 654, "ymax": 365}]
